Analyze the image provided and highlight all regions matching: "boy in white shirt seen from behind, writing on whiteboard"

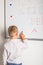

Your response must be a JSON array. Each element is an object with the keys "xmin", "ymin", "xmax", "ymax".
[{"xmin": 3, "ymin": 25, "xmax": 27, "ymax": 65}]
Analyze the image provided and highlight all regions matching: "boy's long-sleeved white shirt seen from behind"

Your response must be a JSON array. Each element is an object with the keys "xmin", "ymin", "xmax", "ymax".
[{"xmin": 3, "ymin": 39, "xmax": 27, "ymax": 65}]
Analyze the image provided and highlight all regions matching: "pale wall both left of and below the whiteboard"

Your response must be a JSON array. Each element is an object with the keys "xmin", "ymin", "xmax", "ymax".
[{"xmin": 0, "ymin": 0, "xmax": 43, "ymax": 65}]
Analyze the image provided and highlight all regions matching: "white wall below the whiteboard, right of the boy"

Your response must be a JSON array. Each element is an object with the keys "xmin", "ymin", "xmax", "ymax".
[{"xmin": 23, "ymin": 41, "xmax": 43, "ymax": 65}]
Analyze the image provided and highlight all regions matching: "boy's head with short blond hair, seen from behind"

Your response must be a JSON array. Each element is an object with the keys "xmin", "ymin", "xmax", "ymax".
[{"xmin": 8, "ymin": 25, "xmax": 18, "ymax": 39}]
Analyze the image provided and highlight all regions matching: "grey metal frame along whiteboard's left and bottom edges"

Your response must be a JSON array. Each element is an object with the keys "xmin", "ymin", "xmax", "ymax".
[{"xmin": 4, "ymin": 0, "xmax": 43, "ymax": 41}]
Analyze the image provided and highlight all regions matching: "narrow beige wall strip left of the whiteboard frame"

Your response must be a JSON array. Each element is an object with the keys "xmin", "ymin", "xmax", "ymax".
[{"xmin": 0, "ymin": 0, "xmax": 4, "ymax": 65}]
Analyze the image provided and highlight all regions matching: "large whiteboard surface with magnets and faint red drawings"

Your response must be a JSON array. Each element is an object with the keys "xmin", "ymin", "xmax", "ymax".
[{"xmin": 5, "ymin": 0, "xmax": 43, "ymax": 39}]
